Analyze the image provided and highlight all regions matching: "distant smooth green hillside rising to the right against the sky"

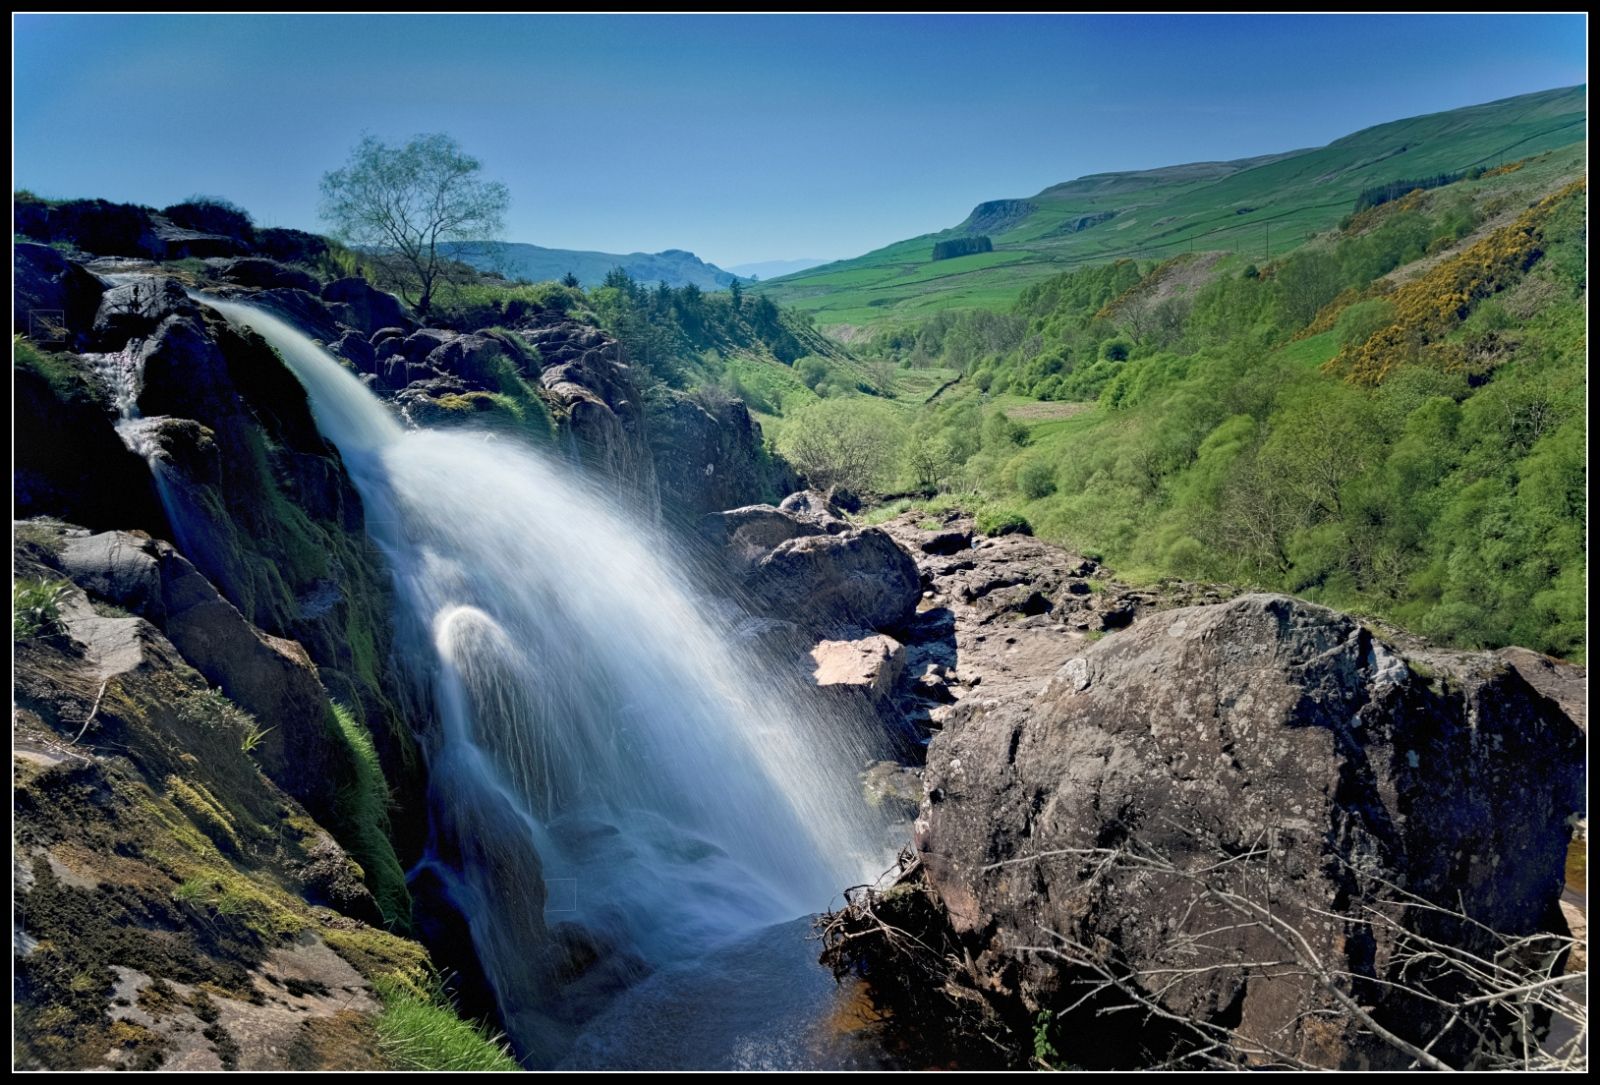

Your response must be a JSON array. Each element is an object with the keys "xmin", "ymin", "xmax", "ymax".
[{"xmin": 755, "ymin": 86, "xmax": 1587, "ymax": 331}]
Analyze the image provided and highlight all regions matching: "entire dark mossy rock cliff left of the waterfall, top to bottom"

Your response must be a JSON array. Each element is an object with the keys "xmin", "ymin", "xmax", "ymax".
[{"xmin": 13, "ymin": 222, "xmax": 508, "ymax": 1069}]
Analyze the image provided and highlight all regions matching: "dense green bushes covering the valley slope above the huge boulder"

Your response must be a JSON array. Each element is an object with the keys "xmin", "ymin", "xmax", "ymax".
[{"xmin": 857, "ymin": 176, "xmax": 1587, "ymax": 659}]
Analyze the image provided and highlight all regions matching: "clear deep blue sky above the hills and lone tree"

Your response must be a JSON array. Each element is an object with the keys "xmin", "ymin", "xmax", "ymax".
[{"xmin": 13, "ymin": 14, "xmax": 1586, "ymax": 264}]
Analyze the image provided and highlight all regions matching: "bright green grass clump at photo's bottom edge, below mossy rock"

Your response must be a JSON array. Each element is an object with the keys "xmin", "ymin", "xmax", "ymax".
[{"xmin": 373, "ymin": 976, "xmax": 522, "ymax": 1071}]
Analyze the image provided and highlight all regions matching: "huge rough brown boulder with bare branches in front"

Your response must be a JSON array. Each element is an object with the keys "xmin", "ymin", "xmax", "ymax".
[{"xmin": 915, "ymin": 595, "xmax": 1584, "ymax": 1067}]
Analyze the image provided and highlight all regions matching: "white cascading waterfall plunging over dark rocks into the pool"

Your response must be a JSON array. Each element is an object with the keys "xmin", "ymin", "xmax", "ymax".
[{"xmin": 205, "ymin": 299, "xmax": 886, "ymax": 1053}]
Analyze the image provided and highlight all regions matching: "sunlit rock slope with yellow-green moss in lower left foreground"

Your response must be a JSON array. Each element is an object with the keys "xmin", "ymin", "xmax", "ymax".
[{"xmin": 13, "ymin": 522, "xmax": 441, "ymax": 1069}]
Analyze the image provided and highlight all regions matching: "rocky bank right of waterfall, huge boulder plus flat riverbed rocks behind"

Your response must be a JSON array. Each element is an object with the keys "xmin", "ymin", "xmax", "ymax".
[{"xmin": 834, "ymin": 517, "xmax": 1584, "ymax": 1067}]
